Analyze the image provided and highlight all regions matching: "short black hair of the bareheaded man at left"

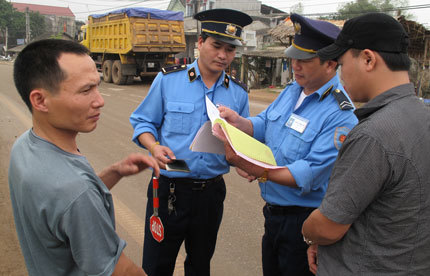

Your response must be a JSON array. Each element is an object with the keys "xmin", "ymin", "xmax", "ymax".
[{"xmin": 13, "ymin": 39, "xmax": 89, "ymax": 111}]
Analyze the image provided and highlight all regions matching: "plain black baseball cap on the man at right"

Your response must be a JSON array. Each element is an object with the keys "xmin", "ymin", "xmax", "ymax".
[{"xmin": 317, "ymin": 13, "xmax": 409, "ymax": 60}]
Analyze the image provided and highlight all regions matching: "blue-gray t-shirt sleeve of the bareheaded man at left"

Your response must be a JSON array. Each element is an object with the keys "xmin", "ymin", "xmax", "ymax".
[{"xmin": 57, "ymin": 188, "xmax": 126, "ymax": 275}]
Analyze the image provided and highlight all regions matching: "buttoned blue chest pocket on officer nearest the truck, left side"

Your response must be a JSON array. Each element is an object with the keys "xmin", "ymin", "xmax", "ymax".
[{"xmin": 164, "ymin": 102, "xmax": 194, "ymax": 134}]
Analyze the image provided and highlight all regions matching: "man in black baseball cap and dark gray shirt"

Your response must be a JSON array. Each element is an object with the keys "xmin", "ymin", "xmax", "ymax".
[{"xmin": 302, "ymin": 13, "xmax": 430, "ymax": 276}]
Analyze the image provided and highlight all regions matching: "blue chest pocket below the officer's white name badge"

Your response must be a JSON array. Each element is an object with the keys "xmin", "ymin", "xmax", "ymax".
[{"xmin": 280, "ymin": 126, "xmax": 318, "ymax": 164}]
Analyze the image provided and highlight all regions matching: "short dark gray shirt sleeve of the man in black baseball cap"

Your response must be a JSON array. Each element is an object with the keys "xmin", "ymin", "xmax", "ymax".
[{"xmin": 319, "ymin": 134, "xmax": 390, "ymax": 224}]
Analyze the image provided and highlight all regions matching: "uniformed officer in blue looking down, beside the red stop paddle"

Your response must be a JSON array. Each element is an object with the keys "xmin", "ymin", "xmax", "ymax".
[{"xmin": 130, "ymin": 9, "xmax": 252, "ymax": 276}]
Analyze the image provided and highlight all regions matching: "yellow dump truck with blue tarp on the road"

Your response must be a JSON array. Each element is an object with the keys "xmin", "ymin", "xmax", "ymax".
[{"xmin": 81, "ymin": 8, "xmax": 185, "ymax": 85}]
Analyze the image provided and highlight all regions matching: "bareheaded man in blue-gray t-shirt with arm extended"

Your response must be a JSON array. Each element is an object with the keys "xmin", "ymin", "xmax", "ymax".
[{"xmin": 9, "ymin": 39, "xmax": 159, "ymax": 276}]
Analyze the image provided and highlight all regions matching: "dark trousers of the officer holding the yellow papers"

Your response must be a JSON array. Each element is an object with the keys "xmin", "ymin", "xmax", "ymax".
[{"xmin": 262, "ymin": 204, "xmax": 314, "ymax": 276}]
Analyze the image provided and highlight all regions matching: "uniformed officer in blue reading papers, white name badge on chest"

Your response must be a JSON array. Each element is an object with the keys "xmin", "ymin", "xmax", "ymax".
[{"xmin": 219, "ymin": 14, "xmax": 357, "ymax": 276}]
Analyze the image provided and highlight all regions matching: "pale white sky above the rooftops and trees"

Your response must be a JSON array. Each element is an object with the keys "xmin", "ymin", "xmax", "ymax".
[{"xmin": 7, "ymin": 0, "xmax": 430, "ymax": 26}]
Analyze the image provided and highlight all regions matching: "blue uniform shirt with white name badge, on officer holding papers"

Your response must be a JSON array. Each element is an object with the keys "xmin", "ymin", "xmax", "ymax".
[{"xmin": 249, "ymin": 75, "xmax": 358, "ymax": 207}]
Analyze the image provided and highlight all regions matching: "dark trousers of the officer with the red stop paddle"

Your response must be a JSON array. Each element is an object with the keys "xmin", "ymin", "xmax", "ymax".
[{"xmin": 142, "ymin": 177, "xmax": 226, "ymax": 276}]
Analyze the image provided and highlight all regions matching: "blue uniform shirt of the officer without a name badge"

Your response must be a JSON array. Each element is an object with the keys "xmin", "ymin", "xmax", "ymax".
[{"xmin": 130, "ymin": 60, "xmax": 249, "ymax": 179}]
